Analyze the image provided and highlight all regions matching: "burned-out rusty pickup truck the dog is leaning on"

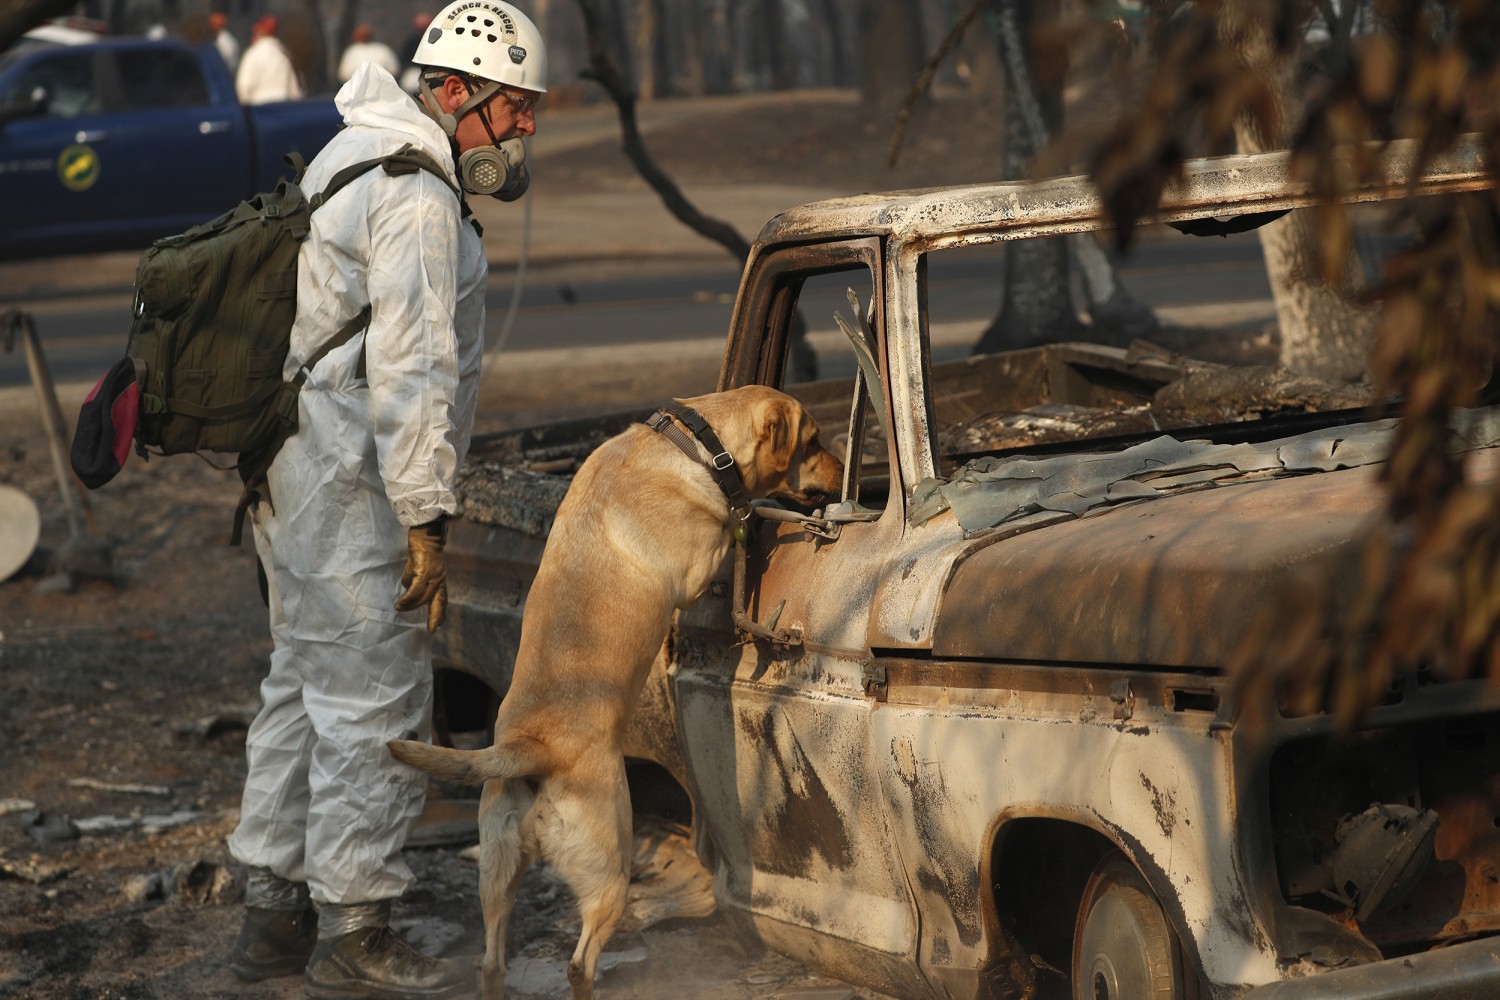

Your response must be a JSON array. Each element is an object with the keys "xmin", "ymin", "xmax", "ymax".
[{"xmin": 438, "ymin": 138, "xmax": 1500, "ymax": 1000}]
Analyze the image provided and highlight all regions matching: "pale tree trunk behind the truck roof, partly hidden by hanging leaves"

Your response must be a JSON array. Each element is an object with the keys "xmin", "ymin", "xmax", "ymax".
[{"xmin": 1221, "ymin": 4, "xmax": 1377, "ymax": 381}]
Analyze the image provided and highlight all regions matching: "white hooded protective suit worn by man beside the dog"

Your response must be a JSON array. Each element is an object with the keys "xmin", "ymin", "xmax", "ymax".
[{"xmin": 230, "ymin": 63, "xmax": 488, "ymax": 904}]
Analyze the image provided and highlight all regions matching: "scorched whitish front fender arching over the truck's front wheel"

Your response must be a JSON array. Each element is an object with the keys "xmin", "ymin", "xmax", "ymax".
[{"xmin": 875, "ymin": 701, "xmax": 1277, "ymax": 996}]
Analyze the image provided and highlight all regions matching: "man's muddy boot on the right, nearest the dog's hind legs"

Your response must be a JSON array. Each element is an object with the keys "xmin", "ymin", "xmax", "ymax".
[{"xmin": 308, "ymin": 903, "xmax": 474, "ymax": 1000}]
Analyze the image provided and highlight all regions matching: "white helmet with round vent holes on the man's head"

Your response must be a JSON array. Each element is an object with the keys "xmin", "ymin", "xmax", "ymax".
[{"xmin": 411, "ymin": 0, "xmax": 548, "ymax": 93}]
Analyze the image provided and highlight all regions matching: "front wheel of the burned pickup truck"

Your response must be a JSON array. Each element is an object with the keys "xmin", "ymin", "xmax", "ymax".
[{"xmin": 1073, "ymin": 853, "xmax": 1197, "ymax": 1000}]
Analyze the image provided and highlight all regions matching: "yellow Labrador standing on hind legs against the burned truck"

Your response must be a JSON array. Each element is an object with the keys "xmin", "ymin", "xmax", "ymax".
[{"xmin": 390, "ymin": 385, "xmax": 843, "ymax": 1000}]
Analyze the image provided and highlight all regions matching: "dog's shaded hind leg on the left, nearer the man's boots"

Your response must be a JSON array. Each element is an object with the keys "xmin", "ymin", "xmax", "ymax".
[{"xmin": 479, "ymin": 780, "xmax": 536, "ymax": 1000}]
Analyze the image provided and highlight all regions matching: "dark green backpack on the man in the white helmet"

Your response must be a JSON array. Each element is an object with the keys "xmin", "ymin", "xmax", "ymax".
[{"xmin": 126, "ymin": 145, "xmax": 462, "ymax": 546}]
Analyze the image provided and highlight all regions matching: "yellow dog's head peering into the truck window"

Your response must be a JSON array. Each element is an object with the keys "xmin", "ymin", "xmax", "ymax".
[{"xmin": 680, "ymin": 385, "xmax": 843, "ymax": 505}]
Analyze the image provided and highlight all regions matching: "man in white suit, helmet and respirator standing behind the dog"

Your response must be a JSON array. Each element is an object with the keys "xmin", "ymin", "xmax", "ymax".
[{"xmin": 230, "ymin": 0, "xmax": 546, "ymax": 999}]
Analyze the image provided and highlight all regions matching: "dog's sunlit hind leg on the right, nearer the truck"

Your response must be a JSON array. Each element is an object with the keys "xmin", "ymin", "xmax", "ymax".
[{"xmin": 537, "ymin": 757, "xmax": 633, "ymax": 1000}]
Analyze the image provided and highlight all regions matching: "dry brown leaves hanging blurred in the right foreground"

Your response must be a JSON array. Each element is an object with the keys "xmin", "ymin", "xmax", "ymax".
[{"xmin": 1092, "ymin": 0, "xmax": 1500, "ymax": 726}]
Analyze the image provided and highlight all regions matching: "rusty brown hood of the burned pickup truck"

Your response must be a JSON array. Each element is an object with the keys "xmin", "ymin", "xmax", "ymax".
[{"xmin": 932, "ymin": 413, "xmax": 1500, "ymax": 669}]
